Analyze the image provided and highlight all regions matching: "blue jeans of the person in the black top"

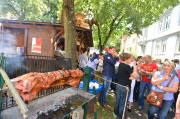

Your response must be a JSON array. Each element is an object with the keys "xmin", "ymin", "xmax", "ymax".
[{"xmin": 114, "ymin": 85, "xmax": 130, "ymax": 119}]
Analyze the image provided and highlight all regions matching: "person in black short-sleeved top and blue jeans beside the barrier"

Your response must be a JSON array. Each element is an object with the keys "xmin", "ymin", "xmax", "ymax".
[{"xmin": 114, "ymin": 53, "xmax": 137, "ymax": 119}]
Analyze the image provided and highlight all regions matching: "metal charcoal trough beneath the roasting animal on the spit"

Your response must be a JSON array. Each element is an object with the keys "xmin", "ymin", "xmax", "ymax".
[{"xmin": 1, "ymin": 87, "xmax": 94, "ymax": 119}]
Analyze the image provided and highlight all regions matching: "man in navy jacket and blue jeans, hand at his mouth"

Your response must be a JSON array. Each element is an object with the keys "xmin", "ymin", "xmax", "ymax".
[{"xmin": 99, "ymin": 47, "xmax": 118, "ymax": 108}]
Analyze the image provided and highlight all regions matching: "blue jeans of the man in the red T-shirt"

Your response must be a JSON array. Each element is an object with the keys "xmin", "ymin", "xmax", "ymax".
[{"xmin": 138, "ymin": 81, "xmax": 152, "ymax": 107}]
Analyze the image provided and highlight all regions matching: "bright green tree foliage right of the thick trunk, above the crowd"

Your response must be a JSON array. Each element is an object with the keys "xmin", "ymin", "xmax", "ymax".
[{"xmin": 75, "ymin": 0, "xmax": 178, "ymax": 48}]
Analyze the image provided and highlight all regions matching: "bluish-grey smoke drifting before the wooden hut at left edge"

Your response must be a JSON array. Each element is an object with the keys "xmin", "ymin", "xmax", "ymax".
[{"xmin": 0, "ymin": 28, "xmax": 28, "ymax": 78}]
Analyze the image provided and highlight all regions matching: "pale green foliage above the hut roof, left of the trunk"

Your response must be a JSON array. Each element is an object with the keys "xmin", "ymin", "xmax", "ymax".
[{"xmin": 0, "ymin": 0, "xmax": 58, "ymax": 22}]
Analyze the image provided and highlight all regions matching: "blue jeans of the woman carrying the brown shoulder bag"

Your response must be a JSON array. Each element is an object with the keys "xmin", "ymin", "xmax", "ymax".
[{"xmin": 148, "ymin": 100, "xmax": 174, "ymax": 119}]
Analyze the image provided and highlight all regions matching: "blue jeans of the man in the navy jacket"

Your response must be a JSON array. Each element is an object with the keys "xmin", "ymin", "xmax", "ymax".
[{"xmin": 99, "ymin": 75, "xmax": 112, "ymax": 106}]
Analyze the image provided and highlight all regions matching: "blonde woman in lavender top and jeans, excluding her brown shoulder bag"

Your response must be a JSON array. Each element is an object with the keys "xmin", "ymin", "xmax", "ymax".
[{"xmin": 148, "ymin": 60, "xmax": 179, "ymax": 119}]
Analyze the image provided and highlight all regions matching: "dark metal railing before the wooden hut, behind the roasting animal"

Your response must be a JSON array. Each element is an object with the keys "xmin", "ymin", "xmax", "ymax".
[{"xmin": 5, "ymin": 54, "xmax": 71, "ymax": 79}]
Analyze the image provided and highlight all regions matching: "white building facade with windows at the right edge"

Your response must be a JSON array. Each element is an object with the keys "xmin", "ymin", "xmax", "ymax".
[{"xmin": 137, "ymin": 4, "xmax": 180, "ymax": 60}]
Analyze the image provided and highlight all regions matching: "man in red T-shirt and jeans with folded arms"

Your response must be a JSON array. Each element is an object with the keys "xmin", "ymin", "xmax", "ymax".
[{"xmin": 138, "ymin": 55, "xmax": 158, "ymax": 109}]
